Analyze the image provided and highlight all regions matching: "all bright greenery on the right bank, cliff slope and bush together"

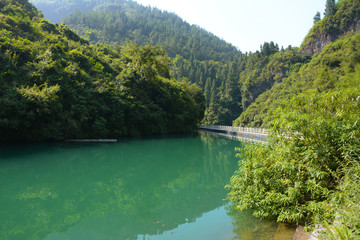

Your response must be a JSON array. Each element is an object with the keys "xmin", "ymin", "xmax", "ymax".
[{"xmin": 228, "ymin": 0, "xmax": 360, "ymax": 236}]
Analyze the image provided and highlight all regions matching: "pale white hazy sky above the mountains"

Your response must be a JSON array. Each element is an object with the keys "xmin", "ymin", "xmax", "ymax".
[{"xmin": 135, "ymin": 0, "xmax": 326, "ymax": 52}]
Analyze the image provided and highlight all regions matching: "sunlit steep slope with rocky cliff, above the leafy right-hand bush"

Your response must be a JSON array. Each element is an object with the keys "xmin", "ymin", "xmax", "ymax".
[{"xmin": 234, "ymin": 0, "xmax": 360, "ymax": 127}]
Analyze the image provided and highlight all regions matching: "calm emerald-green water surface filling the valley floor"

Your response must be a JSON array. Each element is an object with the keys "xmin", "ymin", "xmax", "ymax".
[{"xmin": 0, "ymin": 133, "xmax": 293, "ymax": 240}]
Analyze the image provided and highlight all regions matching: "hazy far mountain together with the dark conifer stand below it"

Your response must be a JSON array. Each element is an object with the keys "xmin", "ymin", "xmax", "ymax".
[{"xmin": 29, "ymin": 0, "xmax": 248, "ymax": 124}]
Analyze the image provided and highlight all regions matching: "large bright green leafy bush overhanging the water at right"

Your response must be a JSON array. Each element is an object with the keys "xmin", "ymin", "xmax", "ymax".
[{"xmin": 229, "ymin": 88, "xmax": 360, "ymax": 229}]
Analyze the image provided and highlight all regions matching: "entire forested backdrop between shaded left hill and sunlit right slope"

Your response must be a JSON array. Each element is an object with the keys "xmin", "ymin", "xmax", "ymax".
[{"xmin": 33, "ymin": 0, "xmax": 308, "ymax": 125}]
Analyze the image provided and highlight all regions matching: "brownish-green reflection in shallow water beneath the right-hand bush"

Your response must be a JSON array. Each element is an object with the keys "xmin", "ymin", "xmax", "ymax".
[{"xmin": 226, "ymin": 204, "xmax": 295, "ymax": 240}]
